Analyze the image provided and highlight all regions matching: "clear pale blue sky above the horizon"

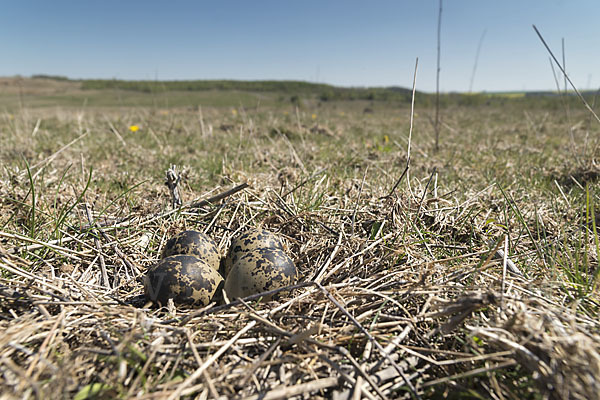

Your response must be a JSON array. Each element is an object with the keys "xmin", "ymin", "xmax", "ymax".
[{"xmin": 0, "ymin": 0, "xmax": 600, "ymax": 91}]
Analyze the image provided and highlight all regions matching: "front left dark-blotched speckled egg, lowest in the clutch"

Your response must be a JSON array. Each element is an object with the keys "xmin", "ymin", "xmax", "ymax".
[{"xmin": 144, "ymin": 255, "xmax": 223, "ymax": 307}]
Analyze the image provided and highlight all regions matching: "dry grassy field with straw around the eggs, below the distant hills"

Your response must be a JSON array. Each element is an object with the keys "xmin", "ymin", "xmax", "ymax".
[{"xmin": 0, "ymin": 79, "xmax": 600, "ymax": 399}]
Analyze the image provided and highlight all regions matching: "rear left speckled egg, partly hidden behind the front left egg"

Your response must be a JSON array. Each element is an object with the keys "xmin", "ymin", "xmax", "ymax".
[{"xmin": 160, "ymin": 231, "xmax": 221, "ymax": 270}]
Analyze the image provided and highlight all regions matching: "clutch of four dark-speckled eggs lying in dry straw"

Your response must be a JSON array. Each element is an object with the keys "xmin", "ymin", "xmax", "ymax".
[{"xmin": 144, "ymin": 229, "xmax": 298, "ymax": 307}]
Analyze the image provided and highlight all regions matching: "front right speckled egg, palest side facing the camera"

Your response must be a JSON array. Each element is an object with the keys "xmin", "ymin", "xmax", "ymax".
[{"xmin": 225, "ymin": 248, "xmax": 298, "ymax": 300}]
